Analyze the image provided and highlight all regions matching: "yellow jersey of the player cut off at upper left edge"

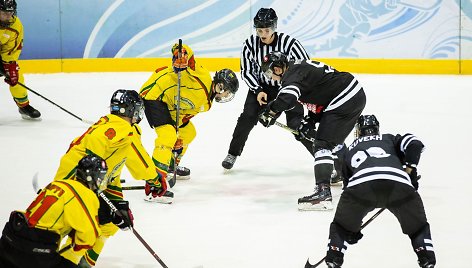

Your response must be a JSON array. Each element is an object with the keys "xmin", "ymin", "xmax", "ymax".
[{"xmin": 0, "ymin": 17, "xmax": 23, "ymax": 62}]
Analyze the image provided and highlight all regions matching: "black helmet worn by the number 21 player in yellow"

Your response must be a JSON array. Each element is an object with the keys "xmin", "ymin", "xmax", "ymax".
[{"xmin": 75, "ymin": 155, "xmax": 108, "ymax": 193}]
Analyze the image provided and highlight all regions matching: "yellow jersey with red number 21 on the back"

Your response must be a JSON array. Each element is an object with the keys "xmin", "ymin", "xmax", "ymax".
[{"xmin": 25, "ymin": 180, "xmax": 100, "ymax": 262}]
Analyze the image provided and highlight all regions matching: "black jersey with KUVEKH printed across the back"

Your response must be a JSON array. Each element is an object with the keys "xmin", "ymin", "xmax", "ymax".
[{"xmin": 343, "ymin": 134, "xmax": 424, "ymax": 187}]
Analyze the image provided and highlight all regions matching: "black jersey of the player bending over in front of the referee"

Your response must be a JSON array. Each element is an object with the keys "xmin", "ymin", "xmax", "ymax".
[{"xmin": 271, "ymin": 60, "xmax": 362, "ymax": 114}]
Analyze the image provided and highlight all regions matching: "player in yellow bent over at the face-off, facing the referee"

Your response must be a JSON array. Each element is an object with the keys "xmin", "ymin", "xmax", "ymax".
[{"xmin": 139, "ymin": 44, "xmax": 239, "ymax": 202}]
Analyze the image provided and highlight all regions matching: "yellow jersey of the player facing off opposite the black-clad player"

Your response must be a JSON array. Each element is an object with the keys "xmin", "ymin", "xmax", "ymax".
[{"xmin": 139, "ymin": 65, "xmax": 213, "ymax": 125}]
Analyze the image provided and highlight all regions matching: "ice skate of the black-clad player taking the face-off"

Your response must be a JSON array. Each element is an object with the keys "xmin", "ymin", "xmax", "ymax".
[{"xmin": 298, "ymin": 183, "xmax": 333, "ymax": 211}]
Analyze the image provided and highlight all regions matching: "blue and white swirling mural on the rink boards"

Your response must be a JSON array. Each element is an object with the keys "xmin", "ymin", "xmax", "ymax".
[{"xmin": 17, "ymin": 0, "xmax": 472, "ymax": 59}]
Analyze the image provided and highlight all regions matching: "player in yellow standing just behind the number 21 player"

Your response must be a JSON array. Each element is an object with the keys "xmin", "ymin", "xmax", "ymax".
[{"xmin": 54, "ymin": 89, "xmax": 173, "ymax": 267}]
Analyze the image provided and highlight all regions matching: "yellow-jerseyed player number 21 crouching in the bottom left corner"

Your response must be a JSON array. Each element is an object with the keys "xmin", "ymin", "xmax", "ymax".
[{"xmin": 0, "ymin": 155, "xmax": 107, "ymax": 268}]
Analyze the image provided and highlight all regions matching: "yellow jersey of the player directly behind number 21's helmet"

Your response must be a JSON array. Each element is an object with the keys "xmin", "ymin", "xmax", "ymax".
[{"xmin": 54, "ymin": 114, "xmax": 157, "ymax": 199}]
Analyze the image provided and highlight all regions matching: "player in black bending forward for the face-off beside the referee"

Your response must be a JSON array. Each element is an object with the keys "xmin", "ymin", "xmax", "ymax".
[{"xmin": 261, "ymin": 52, "xmax": 366, "ymax": 210}]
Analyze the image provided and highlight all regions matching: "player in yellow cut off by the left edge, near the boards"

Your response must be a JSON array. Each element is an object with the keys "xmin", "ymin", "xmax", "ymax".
[{"xmin": 0, "ymin": 0, "xmax": 41, "ymax": 119}]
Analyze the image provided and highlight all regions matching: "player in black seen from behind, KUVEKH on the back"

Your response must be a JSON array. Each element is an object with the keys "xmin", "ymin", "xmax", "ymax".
[{"xmin": 325, "ymin": 115, "xmax": 436, "ymax": 268}]
